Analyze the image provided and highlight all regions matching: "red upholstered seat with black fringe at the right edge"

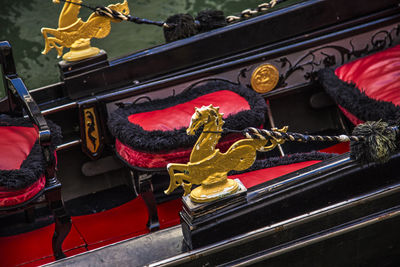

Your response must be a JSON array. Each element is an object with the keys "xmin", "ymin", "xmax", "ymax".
[{"xmin": 319, "ymin": 45, "xmax": 400, "ymax": 124}]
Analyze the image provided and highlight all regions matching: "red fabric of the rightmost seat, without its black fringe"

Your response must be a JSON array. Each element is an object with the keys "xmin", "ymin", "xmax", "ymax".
[{"xmin": 335, "ymin": 45, "xmax": 400, "ymax": 124}]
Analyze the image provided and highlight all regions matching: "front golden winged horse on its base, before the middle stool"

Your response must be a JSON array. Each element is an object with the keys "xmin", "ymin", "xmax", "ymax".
[{"xmin": 165, "ymin": 105, "xmax": 287, "ymax": 203}]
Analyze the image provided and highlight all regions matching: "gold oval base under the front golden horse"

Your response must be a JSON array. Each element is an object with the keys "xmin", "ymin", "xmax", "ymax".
[{"xmin": 190, "ymin": 179, "xmax": 239, "ymax": 203}]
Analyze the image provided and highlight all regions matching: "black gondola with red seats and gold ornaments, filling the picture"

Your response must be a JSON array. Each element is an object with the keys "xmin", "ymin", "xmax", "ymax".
[{"xmin": 0, "ymin": 0, "xmax": 400, "ymax": 266}]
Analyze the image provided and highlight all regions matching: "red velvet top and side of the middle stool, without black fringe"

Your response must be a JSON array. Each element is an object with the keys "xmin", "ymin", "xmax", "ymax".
[{"xmin": 115, "ymin": 90, "xmax": 258, "ymax": 168}]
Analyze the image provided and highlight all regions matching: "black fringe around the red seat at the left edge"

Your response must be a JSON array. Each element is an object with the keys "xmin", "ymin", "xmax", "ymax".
[{"xmin": 0, "ymin": 115, "xmax": 62, "ymax": 192}]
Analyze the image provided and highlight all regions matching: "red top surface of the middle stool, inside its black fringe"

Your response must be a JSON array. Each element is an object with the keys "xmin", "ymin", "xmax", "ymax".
[{"xmin": 128, "ymin": 90, "xmax": 250, "ymax": 131}]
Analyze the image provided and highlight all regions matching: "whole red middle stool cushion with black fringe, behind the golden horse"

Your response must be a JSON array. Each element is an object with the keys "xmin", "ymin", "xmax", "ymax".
[{"xmin": 109, "ymin": 81, "xmax": 265, "ymax": 168}]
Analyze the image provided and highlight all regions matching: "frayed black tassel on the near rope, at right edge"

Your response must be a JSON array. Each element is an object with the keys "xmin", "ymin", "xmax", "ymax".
[{"xmin": 350, "ymin": 121, "xmax": 398, "ymax": 163}]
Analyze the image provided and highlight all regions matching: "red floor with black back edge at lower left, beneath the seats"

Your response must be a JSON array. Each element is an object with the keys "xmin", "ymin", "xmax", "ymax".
[{"xmin": 0, "ymin": 186, "xmax": 181, "ymax": 266}]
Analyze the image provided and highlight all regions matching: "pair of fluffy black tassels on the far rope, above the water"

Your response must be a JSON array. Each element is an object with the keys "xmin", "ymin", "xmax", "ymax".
[{"xmin": 164, "ymin": 10, "xmax": 228, "ymax": 43}]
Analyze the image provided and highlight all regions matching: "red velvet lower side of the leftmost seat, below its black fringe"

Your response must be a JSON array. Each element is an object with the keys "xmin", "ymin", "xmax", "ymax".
[{"xmin": 0, "ymin": 175, "xmax": 46, "ymax": 207}]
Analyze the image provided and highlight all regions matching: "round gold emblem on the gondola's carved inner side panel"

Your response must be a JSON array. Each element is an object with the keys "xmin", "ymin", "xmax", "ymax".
[{"xmin": 251, "ymin": 64, "xmax": 279, "ymax": 93}]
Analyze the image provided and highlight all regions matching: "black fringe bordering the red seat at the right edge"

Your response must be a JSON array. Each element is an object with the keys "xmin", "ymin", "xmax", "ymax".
[{"xmin": 318, "ymin": 68, "xmax": 400, "ymax": 121}]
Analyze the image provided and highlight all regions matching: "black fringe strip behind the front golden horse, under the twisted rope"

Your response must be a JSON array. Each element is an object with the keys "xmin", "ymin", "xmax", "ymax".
[{"xmin": 228, "ymin": 151, "xmax": 338, "ymax": 175}]
